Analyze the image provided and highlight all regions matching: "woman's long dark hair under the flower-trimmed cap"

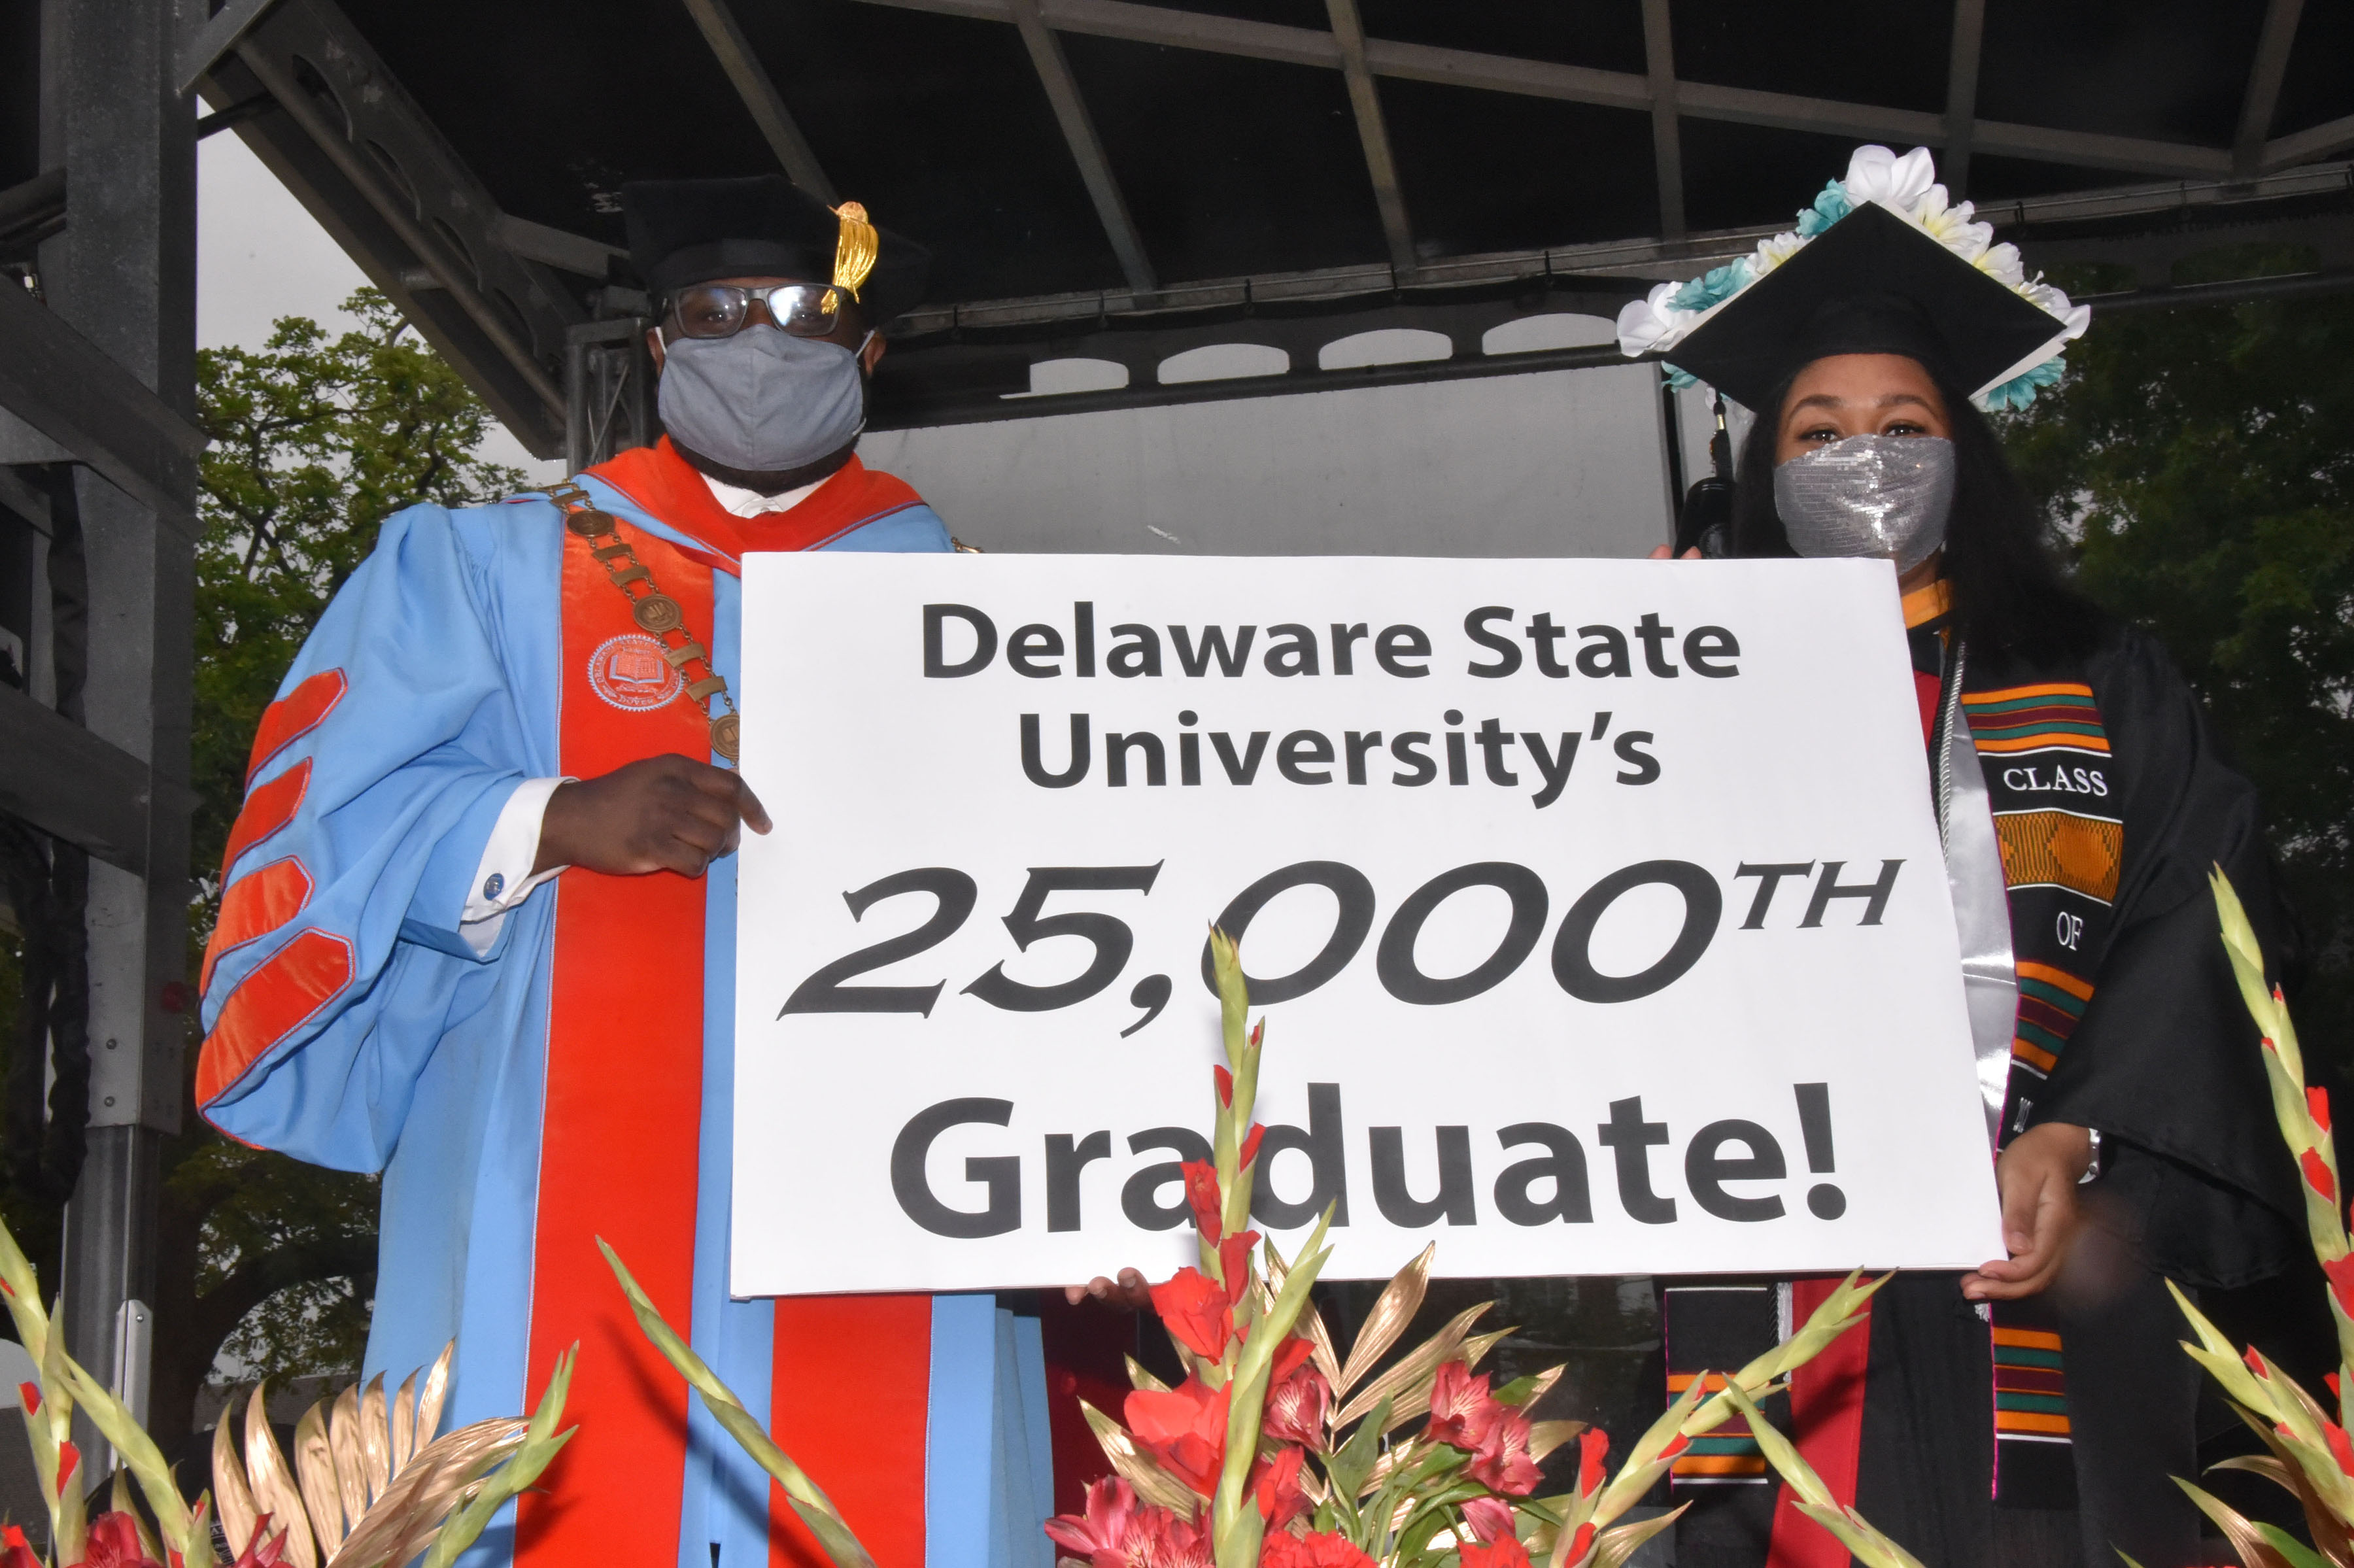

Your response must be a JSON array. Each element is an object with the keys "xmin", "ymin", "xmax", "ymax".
[{"xmin": 1733, "ymin": 365, "xmax": 2109, "ymax": 659}]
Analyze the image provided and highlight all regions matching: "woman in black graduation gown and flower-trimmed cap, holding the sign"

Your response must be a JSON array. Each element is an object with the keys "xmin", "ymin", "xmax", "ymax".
[{"xmin": 1620, "ymin": 148, "xmax": 2302, "ymax": 1568}]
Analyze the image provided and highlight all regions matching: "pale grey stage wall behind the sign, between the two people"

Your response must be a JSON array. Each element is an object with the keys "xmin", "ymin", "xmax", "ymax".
[{"xmin": 859, "ymin": 353, "xmax": 1671, "ymax": 556}]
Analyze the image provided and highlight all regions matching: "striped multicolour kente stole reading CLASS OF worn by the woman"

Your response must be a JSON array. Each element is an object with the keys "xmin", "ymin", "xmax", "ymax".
[{"xmin": 1662, "ymin": 664, "xmax": 2126, "ymax": 1568}]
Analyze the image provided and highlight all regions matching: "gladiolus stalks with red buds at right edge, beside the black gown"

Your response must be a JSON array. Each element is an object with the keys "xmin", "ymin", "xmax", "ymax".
[{"xmin": 2128, "ymin": 869, "xmax": 2354, "ymax": 1568}]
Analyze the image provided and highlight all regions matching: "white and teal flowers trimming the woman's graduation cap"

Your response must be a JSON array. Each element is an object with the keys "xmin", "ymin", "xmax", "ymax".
[{"xmin": 1617, "ymin": 146, "xmax": 2092, "ymax": 410}]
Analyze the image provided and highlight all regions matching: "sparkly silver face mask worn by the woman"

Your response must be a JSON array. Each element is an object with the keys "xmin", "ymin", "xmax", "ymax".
[{"xmin": 1773, "ymin": 435, "xmax": 1954, "ymax": 575}]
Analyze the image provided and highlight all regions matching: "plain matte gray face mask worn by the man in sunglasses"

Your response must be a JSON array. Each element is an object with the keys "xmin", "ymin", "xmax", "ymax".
[{"xmin": 655, "ymin": 325, "xmax": 866, "ymax": 473}]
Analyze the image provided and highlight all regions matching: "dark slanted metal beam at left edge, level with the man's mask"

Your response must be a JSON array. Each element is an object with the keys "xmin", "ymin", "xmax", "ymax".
[{"xmin": 0, "ymin": 277, "xmax": 205, "ymax": 539}]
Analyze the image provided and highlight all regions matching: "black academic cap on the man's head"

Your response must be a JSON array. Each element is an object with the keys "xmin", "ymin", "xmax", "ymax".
[{"xmin": 621, "ymin": 174, "xmax": 932, "ymax": 325}]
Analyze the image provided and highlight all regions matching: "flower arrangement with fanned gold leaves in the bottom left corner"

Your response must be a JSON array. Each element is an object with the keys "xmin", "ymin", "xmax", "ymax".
[{"xmin": 0, "ymin": 1224, "xmax": 579, "ymax": 1568}]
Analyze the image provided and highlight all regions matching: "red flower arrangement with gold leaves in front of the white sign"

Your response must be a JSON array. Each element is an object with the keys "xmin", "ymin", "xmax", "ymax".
[{"xmin": 1045, "ymin": 932, "xmax": 1911, "ymax": 1568}]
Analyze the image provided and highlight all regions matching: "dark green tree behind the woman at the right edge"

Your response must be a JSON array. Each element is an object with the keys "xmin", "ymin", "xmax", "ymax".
[{"xmin": 2005, "ymin": 250, "xmax": 2354, "ymax": 1069}]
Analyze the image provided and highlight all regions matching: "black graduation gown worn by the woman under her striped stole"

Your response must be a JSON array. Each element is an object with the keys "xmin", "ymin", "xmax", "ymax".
[{"xmin": 1676, "ymin": 622, "xmax": 2307, "ymax": 1568}]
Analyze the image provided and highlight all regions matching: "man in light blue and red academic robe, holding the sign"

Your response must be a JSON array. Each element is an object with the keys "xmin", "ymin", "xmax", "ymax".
[{"xmin": 197, "ymin": 177, "xmax": 1043, "ymax": 1568}]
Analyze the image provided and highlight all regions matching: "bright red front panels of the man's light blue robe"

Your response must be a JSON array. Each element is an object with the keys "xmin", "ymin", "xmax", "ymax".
[{"xmin": 515, "ymin": 516, "xmax": 930, "ymax": 1568}]
